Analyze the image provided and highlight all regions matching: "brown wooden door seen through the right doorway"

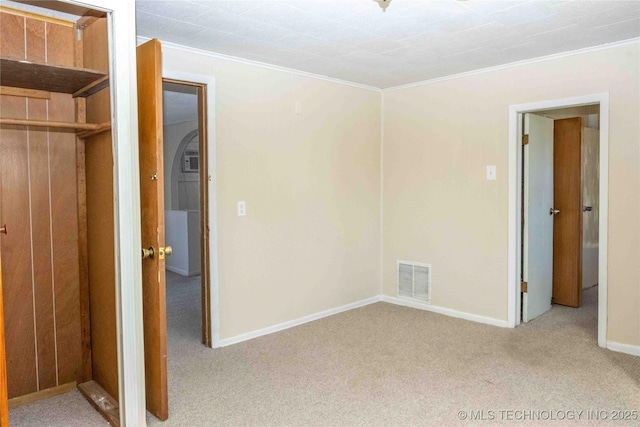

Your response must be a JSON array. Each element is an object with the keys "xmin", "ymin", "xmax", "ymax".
[{"xmin": 553, "ymin": 117, "xmax": 582, "ymax": 307}]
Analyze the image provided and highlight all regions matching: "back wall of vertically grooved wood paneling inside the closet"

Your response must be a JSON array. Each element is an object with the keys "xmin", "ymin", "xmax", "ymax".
[{"xmin": 0, "ymin": 13, "xmax": 82, "ymax": 398}]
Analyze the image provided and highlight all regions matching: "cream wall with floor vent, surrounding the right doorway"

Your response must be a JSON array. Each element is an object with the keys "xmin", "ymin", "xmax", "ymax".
[{"xmin": 383, "ymin": 43, "xmax": 640, "ymax": 345}]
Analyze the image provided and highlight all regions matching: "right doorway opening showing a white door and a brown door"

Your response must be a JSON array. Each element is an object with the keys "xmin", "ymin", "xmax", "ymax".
[{"xmin": 521, "ymin": 104, "xmax": 599, "ymax": 322}]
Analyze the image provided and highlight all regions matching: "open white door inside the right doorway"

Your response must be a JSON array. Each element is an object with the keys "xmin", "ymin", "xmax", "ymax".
[{"xmin": 522, "ymin": 114, "xmax": 553, "ymax": 322}]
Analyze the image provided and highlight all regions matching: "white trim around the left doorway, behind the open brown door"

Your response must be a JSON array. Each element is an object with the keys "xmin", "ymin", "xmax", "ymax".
[{"xmin": 161, "ymin": 67, "xmax": 220, "ymax": 348}]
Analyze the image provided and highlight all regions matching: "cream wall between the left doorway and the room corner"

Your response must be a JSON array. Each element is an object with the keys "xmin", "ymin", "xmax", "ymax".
[{"xmin": 163, "ymin": 45, "xmax": 381, "ymax": 339}]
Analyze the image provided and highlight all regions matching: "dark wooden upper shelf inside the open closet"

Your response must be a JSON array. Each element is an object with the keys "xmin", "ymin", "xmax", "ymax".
[{"xmin": 0, "ymin": 58, "xmax": 109, "ymax": 97}]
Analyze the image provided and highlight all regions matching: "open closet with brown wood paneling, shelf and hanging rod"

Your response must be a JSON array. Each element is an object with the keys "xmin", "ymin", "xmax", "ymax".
[{"xmin": 0, "ymin": 5, "xmax": 118, "ymax": 427}]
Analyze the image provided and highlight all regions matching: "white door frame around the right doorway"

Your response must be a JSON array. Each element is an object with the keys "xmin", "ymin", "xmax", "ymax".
[{"xmin": 507, "ymin": 92, "xmax": 609, "ymax": 348}]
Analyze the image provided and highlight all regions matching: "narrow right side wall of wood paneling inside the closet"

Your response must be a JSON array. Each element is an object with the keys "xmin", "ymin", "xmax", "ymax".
[{"xmin": 83, "ymin": 18, "xmax": 118, "ymax": 399}]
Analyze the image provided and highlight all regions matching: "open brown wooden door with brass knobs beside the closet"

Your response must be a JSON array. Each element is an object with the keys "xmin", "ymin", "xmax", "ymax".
[{"xmin": 137, "ymin": 39, "xmax": 169, "ymax": 420}]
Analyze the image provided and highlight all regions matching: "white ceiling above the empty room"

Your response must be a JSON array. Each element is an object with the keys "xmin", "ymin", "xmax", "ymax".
[{"xmin": 136, "ymin": 0, "xmax": 640, "ymax": 88}]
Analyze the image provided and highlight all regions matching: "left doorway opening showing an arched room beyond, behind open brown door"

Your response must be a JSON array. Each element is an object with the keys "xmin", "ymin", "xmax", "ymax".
[{"xmin": 162, "ymin": 78, "xmax": 212, "ymax": 347}]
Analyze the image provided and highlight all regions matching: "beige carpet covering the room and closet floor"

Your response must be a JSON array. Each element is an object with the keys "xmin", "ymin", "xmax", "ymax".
[{"xmin": 11, "ymin": 283, "xmax": 640, "ymax": 426}]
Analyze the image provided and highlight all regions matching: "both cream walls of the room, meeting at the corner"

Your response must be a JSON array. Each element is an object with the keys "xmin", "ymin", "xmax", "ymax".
[{"xmin": 164, "ymin": 39, "xmax": 640, "ymax": 352}]
